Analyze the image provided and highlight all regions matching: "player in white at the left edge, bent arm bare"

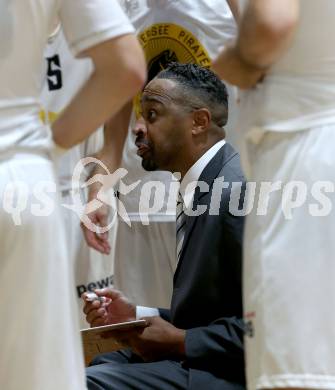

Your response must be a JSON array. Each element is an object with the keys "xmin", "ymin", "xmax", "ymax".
[{"xmin": 0, "ymin": 0, "xmax": 144, "ymax": 390}]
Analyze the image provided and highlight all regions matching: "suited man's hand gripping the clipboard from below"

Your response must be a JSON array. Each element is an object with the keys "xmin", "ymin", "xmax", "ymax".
[{"xmin": 119, "ymin": 317, "xmax": 186, "ymax": 362}]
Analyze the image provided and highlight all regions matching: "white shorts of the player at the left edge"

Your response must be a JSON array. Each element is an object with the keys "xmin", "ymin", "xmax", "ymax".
[{"xmin": 0, "ymin": 153, "xmax": 86, "ymax": 390}]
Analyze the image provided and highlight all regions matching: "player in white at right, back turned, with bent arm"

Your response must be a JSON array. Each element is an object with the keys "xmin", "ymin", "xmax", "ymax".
[{"xmin": 215, "ymin": 0, "xmax": 335, "ymax": 390}]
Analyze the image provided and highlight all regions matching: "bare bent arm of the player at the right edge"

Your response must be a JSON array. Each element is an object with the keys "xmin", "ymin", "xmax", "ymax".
[{"xmin": 213, "ymin": 0, "xmax": 299, "ymax": 88}]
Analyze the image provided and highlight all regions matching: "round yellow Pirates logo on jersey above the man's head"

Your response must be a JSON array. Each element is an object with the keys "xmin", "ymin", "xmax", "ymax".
[{"xmin": 135, "ymin": 23, "xmax": 211, "ymax": 116}]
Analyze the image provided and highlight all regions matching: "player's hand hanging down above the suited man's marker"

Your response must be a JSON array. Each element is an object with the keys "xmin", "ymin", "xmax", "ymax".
[{"xmin": 81, "ymin": 184, "xmax": 111, "ymax": 255}]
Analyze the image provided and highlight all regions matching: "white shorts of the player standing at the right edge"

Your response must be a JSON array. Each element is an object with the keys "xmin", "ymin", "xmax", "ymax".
[{"xmin": 244, "ymin": 125, "xmax": 335, "ymax": 390}]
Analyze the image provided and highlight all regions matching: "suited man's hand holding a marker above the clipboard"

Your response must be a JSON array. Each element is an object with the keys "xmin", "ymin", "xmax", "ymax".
[{"xmin": 82, "ymin": 288, "xmax": 136, "ymax": 327}]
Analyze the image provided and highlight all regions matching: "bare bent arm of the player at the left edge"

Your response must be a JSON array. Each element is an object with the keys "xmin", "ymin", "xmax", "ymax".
[{"xmin": 53, "ymin": 34, "xmax": 146, "ymax": 148}]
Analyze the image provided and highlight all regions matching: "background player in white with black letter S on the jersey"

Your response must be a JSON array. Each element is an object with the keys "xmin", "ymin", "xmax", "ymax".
[{"xmin": 41, "ymin": 25, "xmax": 116, "ymax": 328}]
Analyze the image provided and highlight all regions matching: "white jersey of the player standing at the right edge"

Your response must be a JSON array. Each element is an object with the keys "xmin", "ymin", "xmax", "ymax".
[{"xmin": 241, "ymin": 0, "xmax": 335, "ymax": 131}]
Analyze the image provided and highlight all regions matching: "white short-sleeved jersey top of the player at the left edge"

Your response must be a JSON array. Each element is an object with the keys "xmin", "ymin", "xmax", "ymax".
[{"xmin": 0, "ymin": 0, "xmax": 132, "ymax": 156}]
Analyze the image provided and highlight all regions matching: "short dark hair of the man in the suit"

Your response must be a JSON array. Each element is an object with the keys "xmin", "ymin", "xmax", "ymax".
[{"xmin": 157, "ymin": 62, "xmax": 228, "ymax": 127}]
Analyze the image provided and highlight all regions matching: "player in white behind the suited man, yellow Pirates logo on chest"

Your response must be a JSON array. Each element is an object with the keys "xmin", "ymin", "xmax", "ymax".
[{"xmin": 81, "ymin": 0, "xmax": 236, "ymax": 307}]
